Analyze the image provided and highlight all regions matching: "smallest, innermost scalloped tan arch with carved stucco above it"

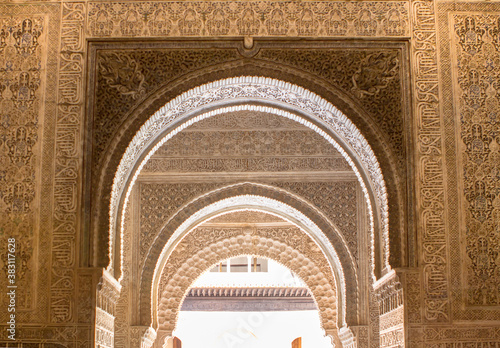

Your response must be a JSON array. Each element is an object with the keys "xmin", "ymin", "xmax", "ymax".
[{"xmin": 158, "ymin": 228, "xmax": 339, "ymax": 342}]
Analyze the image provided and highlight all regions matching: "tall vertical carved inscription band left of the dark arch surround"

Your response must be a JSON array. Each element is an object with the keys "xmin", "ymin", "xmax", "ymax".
[{"xmin": 50, "ymin": 2, "xmax": 86, "ymax": 323}]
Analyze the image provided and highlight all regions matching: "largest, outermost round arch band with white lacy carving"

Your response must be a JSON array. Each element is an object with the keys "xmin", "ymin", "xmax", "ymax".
[{"xmin": 108, "ymin": 77, "xmax": 390, "ymax": 282}]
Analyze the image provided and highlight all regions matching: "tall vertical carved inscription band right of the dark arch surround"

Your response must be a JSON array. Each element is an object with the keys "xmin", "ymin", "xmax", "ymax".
[{"xmin": 411, "ymin": 0, "xmax": 450, "ymax": 322}]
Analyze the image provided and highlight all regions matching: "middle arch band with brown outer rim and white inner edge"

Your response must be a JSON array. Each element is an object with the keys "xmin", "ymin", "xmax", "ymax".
[{"xmin": 140, "ymin": 183, "xmax": 360, "ymax": 327}]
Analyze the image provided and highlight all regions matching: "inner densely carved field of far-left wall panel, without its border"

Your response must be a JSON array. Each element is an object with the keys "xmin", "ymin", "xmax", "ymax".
[{"xmin": 0, "ymin": 13, "xmax": 44, "ymax": 318}]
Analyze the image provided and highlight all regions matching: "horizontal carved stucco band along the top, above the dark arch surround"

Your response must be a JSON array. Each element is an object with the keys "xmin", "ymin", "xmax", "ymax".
[{"xmin": 87, "ymin": 1, "xmax": 409, "ymax": 38}]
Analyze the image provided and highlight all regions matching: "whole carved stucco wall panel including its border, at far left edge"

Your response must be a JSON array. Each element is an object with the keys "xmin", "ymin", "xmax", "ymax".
[{"xmin": 0, "ymin": 3, "xmax": 60, "ymax": 330}]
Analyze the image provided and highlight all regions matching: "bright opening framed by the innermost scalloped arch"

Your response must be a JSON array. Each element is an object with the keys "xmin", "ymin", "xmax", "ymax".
[{"xmin": 173, "ymin": 255, "xmax": 332, "ymax": 348}]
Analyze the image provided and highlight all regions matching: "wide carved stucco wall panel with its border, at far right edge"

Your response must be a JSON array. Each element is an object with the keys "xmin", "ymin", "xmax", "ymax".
[{"xmin": 438, "ymin": 3, "xmax": 500, "ymax": 324}]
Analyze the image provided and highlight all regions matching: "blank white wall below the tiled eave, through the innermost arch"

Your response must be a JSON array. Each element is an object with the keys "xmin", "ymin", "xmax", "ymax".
[{"xmin": 174, "ymin": 311, "xmax": 332, "ymax": 348}]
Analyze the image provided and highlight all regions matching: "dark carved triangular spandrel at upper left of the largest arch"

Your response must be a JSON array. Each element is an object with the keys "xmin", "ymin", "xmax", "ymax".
[{"xmin": 92, "ymin": 49, "xmax": 240, "ymax": 172}]
